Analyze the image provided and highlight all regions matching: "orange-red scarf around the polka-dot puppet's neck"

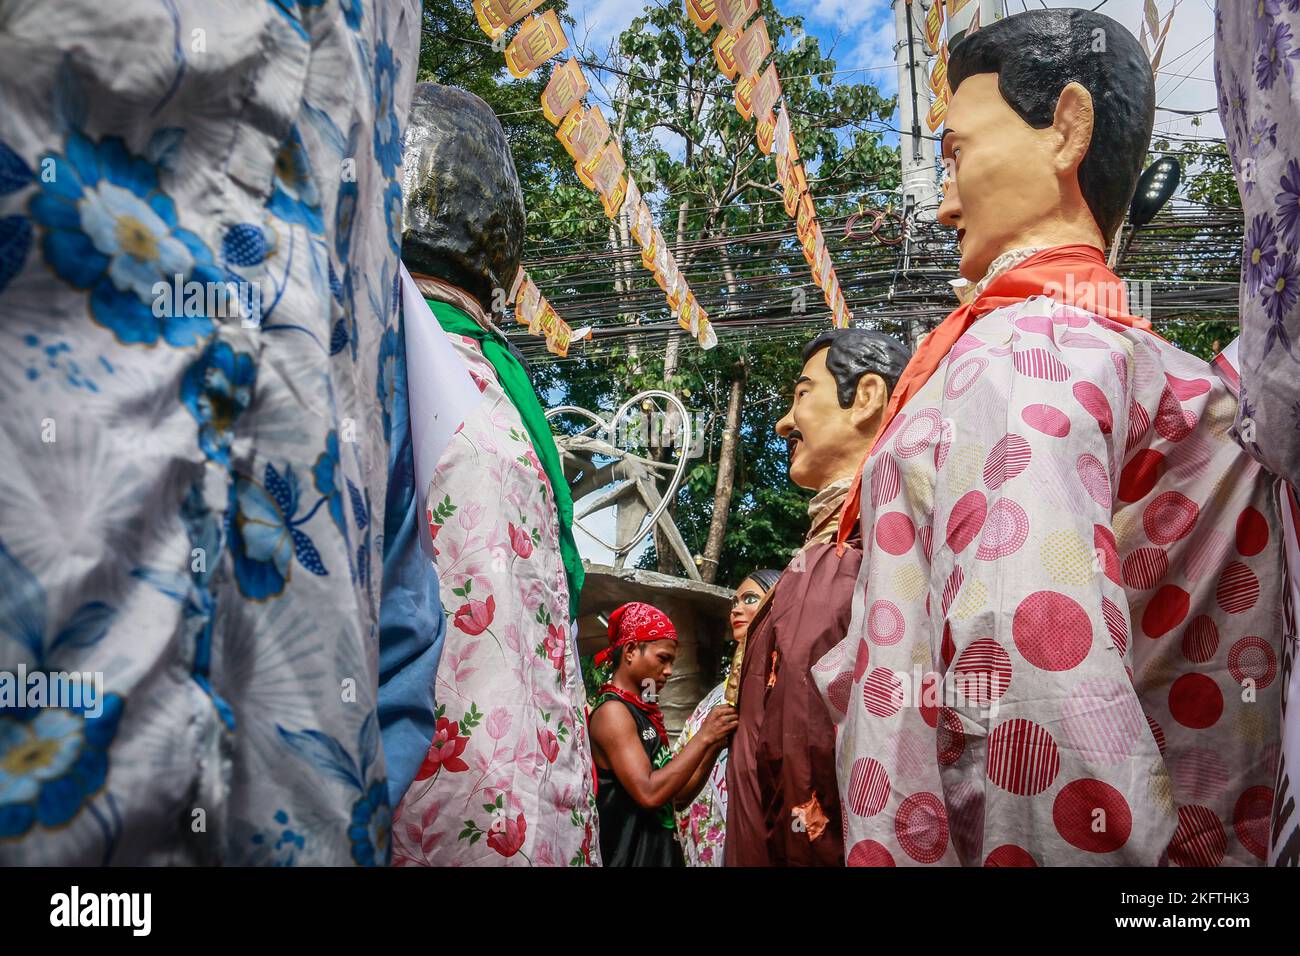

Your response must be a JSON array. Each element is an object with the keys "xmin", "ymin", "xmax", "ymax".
[{"xmin": 836, "ymin": 243, "xmax": 1151, "ymax": 554}]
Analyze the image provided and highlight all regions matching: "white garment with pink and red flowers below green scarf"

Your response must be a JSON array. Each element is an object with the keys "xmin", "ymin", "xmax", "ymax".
[{"xmin": 393, "ymin": 336, "xmax": 601, "ymax": 866}]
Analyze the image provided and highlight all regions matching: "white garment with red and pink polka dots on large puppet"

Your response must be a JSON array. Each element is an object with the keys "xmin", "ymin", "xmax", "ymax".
[{"xmin": 813, "ymin": 297, "xmax": 1283, "ymax": 866}]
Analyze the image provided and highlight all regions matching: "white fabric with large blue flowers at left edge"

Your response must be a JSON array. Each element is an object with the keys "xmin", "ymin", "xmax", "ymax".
[{"xmin": 0, "ymin": 0, "xmax": 418, "ymax": 865}]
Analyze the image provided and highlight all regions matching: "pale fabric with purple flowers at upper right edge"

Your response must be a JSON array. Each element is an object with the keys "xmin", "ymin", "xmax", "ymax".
[{"xmin": 1214, "ymin": 0, "xmax": 1300, "ymax": 483}]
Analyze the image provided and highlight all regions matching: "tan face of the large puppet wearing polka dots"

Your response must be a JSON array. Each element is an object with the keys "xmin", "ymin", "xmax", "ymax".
[{"xmin": 939, "ymin": 73, "xmax": 1091, "ymax": 282}]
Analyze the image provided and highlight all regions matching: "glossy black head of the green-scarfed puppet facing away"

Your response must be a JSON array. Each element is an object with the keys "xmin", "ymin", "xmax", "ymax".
[{"xmin": 402, "ymin": 83, "xmax": 524, "ymax": 312}]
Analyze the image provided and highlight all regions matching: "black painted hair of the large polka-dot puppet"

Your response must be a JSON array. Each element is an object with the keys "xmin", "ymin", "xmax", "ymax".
[{"xmin": 948, "ymin": 8, "xmax": 1156, "ymax": 239}]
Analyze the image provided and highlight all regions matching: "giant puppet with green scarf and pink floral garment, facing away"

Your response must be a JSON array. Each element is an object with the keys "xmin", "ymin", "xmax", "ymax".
[{"xmin": 393, "ymin": 83, "xmax": 599, "ymax": 865}]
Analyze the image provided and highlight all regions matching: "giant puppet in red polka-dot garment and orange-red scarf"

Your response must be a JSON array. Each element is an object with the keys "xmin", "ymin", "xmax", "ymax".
[{"xmin": 813, "ymin": 9, "xmax": 1283, "ymax": 866}]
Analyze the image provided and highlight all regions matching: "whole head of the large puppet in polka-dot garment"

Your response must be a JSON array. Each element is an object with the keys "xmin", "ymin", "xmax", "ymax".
[{"xmin": 939, "ymin": 9, "xmax": 1156, "ymax": 282}]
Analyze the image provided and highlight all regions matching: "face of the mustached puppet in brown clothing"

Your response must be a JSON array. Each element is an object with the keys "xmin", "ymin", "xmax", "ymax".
[{"xmin": 776, "ymin": 349, "xmax": 885, "ymax": 492}]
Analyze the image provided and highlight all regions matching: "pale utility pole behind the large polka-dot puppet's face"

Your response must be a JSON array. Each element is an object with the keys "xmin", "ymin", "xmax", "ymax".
[{"xmin": 889, "ymin": 0, "xmax": 944, "ymax": 349}]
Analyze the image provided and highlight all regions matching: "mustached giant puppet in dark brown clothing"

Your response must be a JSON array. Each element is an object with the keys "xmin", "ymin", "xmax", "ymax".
[{"xmin": 724, "ymin": 329, "xmax": 907, "ymax": 866}]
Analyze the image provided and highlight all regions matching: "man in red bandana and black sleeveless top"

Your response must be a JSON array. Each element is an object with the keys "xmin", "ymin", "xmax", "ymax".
[{"xmin": 590, "ymin": 601, "xmax": 736, "ymax": 866}]
